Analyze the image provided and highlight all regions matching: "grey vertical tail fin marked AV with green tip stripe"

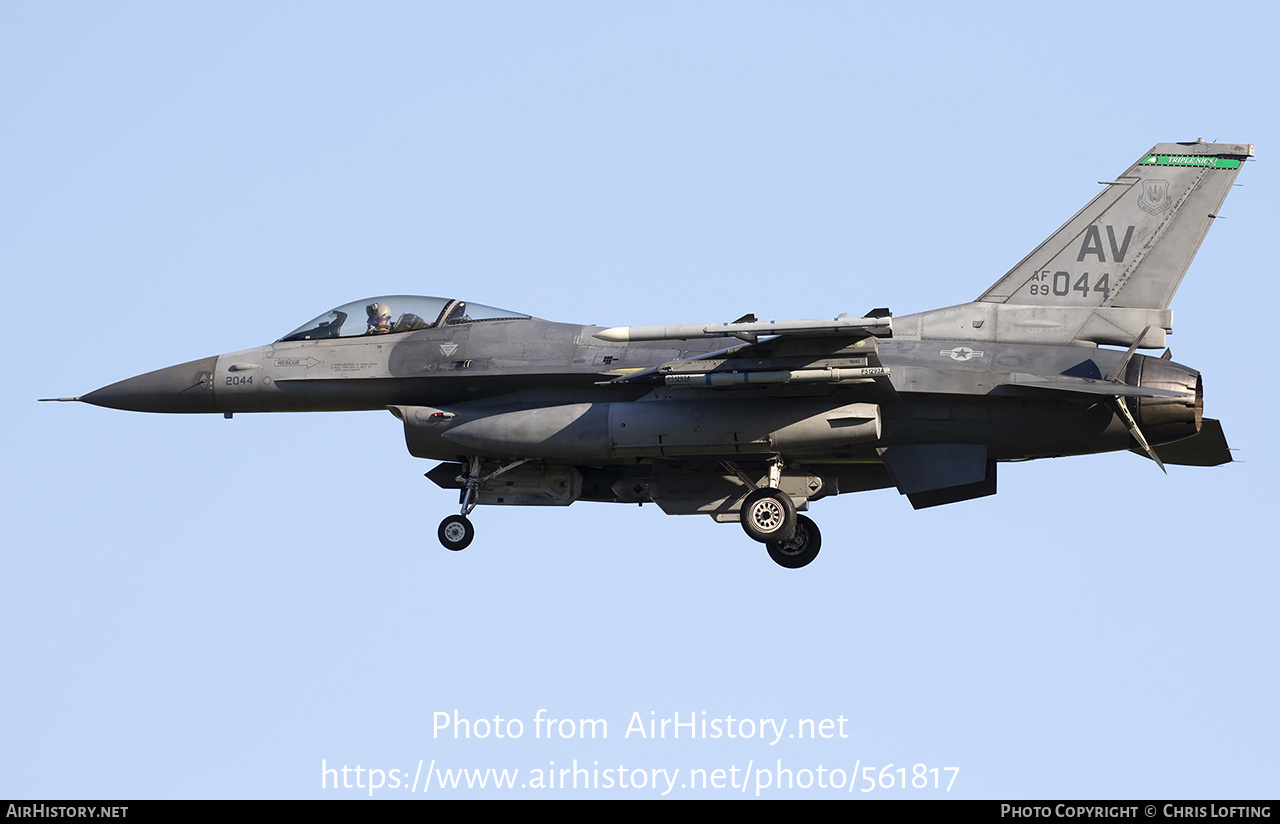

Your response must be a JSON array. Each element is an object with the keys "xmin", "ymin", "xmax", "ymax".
[{"xmin": 978, "ymin": 141, "xmax": 1253, "ymax": 310}]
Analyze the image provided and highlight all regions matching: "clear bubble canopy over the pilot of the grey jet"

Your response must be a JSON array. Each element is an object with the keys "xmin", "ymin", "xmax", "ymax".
[{"xmin": 280, "ymin": 294, "xmax": 530, "ymax": 340}]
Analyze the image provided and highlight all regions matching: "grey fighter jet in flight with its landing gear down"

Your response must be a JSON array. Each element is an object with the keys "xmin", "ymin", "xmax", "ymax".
[{"xmin": 47, "ymin": 141, "xmax": 1253, "ymax": 568}]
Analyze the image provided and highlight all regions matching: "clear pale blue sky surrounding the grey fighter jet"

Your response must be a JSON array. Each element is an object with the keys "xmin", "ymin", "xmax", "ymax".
[{"xmin": 0, "ymin": 1, "xmax": 1280, "ymax": 798}]
